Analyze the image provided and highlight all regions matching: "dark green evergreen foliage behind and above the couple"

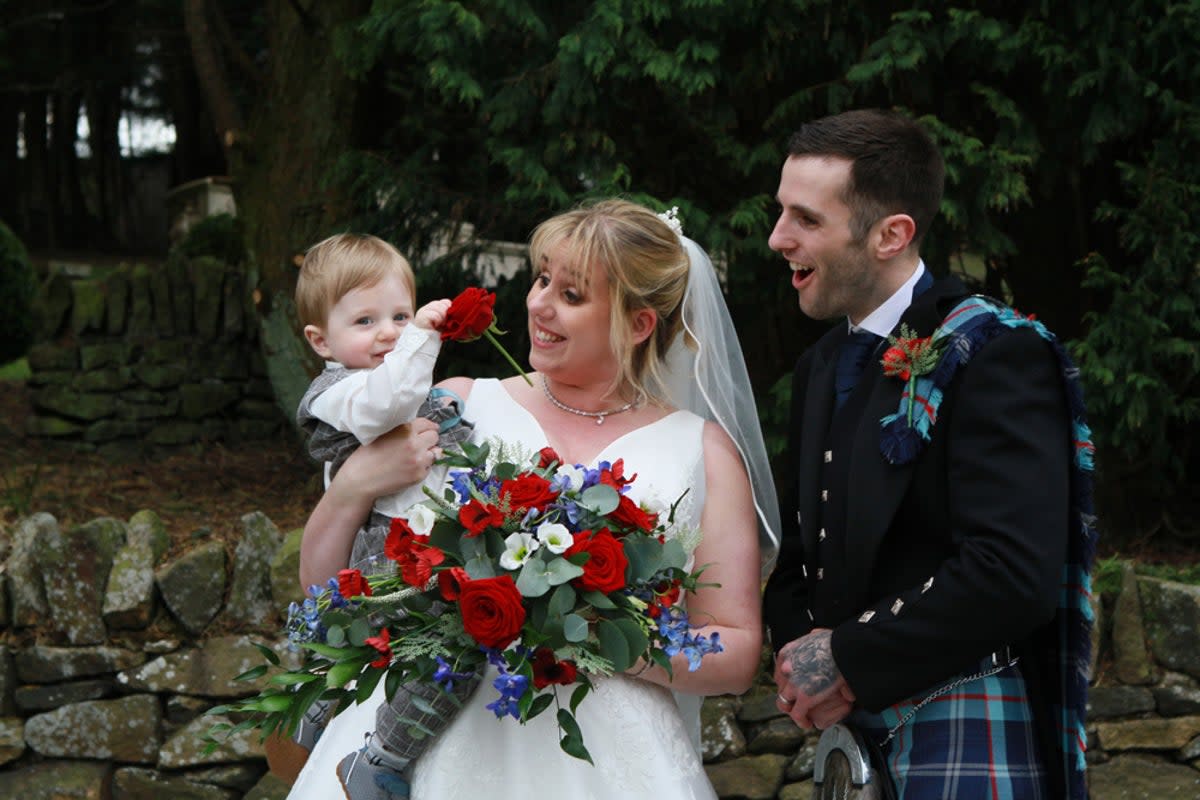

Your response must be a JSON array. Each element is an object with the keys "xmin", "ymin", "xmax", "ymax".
[{"xmin": 312, "ymin": 0, "xmax": 1200, "ymax": 542}]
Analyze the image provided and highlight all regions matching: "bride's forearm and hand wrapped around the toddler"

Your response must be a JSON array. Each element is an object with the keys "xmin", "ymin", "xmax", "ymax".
[{"xmin": 300, "ymin": 419, "xmax": 438, "ymax": 591}]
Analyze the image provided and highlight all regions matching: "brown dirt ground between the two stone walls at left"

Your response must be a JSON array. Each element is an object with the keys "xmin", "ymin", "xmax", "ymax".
[{"xmin": 0, "ymin": 381, "xmax": 322, "ymax": 549}]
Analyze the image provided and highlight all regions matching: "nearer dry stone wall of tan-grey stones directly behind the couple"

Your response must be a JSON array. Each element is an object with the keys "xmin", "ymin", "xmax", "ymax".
[{"xmin": 0, "ymin": 511, "xmax": 1200, "ymax": 800}]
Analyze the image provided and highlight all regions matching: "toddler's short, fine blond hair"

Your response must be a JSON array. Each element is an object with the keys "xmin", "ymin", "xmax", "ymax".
[{"xmin": 295, "ymin": 234, "xmax": 416, "ymax": 327}]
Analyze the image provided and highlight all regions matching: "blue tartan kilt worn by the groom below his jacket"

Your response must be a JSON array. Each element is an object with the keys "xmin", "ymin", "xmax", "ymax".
[{"xmin": 848, "ymin": 657, "xmax": 1050, "ymax": 800}]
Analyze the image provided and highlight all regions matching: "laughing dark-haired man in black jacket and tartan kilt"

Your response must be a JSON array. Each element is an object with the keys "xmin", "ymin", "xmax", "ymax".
[{"xmin": 764, "ymin": 110, "xmax": 1091, "ymax": 798}]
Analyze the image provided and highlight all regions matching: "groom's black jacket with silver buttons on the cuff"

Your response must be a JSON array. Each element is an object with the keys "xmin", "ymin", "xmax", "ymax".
[{"xmin": 764, "ymin": 278, "xmax": 1073, "ymax": 734}]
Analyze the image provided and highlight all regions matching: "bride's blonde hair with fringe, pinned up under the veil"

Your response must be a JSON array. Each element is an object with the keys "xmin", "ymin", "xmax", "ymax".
[{"xmin": 529, "ymin": 200, "xmax": 689, "ymax": 405}]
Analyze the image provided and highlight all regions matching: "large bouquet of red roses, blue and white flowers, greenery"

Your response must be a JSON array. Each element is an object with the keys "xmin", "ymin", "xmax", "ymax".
[{"xmin": 214, "ymin": 443, "xmax": 721, "ymax": 762}]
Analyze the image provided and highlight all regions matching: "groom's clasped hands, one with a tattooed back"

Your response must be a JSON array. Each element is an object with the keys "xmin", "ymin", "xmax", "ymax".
[{"xmin": 775, "ymin": 628, "xmax": 854, "ymax": 730}]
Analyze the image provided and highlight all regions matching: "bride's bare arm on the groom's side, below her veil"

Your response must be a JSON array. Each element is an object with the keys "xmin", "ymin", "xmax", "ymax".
[{"xmin": 631, "ymin": 422, "xmax": 762, "ymax": 694}]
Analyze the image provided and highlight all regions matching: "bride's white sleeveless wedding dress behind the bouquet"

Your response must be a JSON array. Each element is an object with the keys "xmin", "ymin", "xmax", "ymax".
[{"xmin": 288, "ymin": 379, "xmax": 716, "ymax": 800}]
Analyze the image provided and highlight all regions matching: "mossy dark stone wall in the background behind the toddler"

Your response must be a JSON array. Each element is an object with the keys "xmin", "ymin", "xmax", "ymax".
[{"xmin": 28, "ymin": 253, "xmax": 286, "ymax": 446}]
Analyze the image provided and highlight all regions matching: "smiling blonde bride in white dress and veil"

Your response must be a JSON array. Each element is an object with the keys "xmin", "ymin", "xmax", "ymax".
[{"xmin": 288, "ymin": 200, "xmax": 778, "ymax": 800}]
